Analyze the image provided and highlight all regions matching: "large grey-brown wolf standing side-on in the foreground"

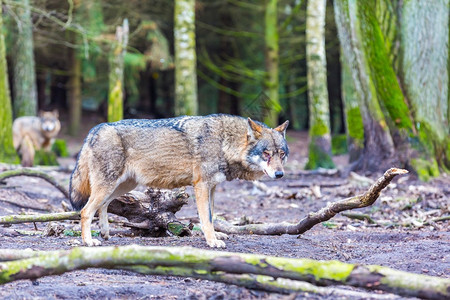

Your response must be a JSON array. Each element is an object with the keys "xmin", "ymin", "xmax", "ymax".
[{"xmin": 69, "ymin": 114, "xmax": 289, "ymax": 248}]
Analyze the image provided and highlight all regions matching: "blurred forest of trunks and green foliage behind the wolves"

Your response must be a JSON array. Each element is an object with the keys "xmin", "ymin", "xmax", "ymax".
[{"xmin": 2, "ymin": 0, "xmax": 450, "ymax": 179}]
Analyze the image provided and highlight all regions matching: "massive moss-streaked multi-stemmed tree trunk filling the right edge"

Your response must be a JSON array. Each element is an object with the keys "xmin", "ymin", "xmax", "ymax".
[{"xmin": 334, "ymin": 0, "xmax": 450, "ymax": 180}]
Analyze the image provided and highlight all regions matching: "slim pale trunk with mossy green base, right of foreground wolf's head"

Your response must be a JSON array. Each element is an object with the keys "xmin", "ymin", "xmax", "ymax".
[{"xmin": 305, "ymin": 0, "xmax": 334, "ymax": 169}]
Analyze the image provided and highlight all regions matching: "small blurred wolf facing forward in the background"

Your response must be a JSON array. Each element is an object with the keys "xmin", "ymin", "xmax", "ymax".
[{"xmin": 13, "ymin": 110, "xmax": 61, "ymax": 167}]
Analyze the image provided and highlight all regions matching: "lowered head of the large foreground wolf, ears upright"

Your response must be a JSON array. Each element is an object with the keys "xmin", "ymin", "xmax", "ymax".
[{"xmin": 247, "ymin": 118, "xmax": 289, "ymax": 178}]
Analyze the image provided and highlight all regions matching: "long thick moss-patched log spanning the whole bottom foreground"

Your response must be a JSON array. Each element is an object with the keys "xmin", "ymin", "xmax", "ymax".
[{"xmin": 0, "ymin": 245, "xmax": 444, "ymax": 299}]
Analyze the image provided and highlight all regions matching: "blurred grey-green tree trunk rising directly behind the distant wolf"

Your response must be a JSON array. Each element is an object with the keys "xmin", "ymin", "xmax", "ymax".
[{"xmin": 11, "ymin": 0, "xmax": 37, "ymax": 118}]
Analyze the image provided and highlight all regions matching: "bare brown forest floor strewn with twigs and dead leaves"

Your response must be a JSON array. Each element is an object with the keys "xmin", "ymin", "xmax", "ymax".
[{"xmin": 0, "ymin": 118, "xmax": 450, "ymax": 299}]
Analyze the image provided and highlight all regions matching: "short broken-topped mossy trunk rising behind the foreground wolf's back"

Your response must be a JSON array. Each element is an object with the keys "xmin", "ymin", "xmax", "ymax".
[{"xmin": 108, "ymin": 19, "xmax": 129, "ymax": 122}]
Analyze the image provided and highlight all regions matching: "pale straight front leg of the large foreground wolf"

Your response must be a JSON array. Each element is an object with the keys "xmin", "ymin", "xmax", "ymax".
[{"xmin": 194, "ymin": 181, "xmax": 225, "ymax": 248}]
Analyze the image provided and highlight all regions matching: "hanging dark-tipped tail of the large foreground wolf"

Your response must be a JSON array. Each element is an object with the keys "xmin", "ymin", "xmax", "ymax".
[{"xmin": 69, "ymin": 147, "xmax": 91, "ymax": 210}]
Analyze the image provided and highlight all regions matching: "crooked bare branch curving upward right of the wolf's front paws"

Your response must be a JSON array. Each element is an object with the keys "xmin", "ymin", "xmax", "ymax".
[{"xmin": 214, "ymin": 168, "xmax": 408, "ymax": 235}]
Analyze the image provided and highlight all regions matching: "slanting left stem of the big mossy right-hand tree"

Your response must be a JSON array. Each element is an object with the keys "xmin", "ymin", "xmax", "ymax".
[{"xmin": 334, "ymin": 0, "xmax": 395, "ymax": 171}]
